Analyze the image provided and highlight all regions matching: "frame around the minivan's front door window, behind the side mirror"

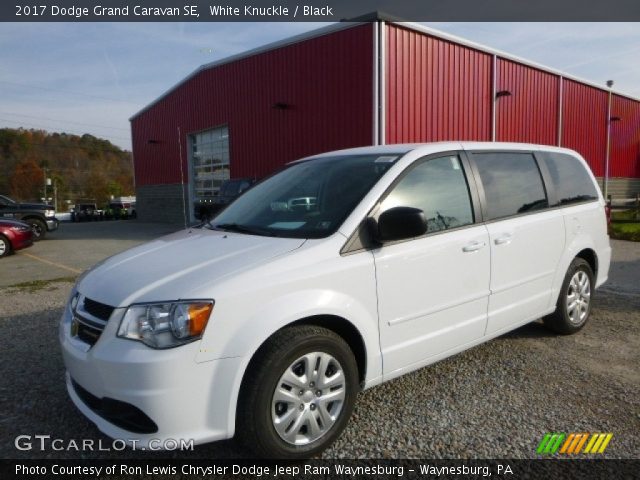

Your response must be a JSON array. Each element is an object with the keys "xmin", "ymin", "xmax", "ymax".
[{"xmin": 340, "ymin": 150, "xmax": 484, "ymax": 256}]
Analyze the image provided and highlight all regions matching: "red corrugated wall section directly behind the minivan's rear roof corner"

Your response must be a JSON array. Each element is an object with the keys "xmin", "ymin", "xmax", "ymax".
[{"xmin": 561, "ymin": 79, "xmax": 608, "ymax": 177}]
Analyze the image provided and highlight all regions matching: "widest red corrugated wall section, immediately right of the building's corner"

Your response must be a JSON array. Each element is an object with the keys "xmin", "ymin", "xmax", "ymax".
[{"xmin": 385, "ymin": 25, "xmax": 492, "ymax": 143}]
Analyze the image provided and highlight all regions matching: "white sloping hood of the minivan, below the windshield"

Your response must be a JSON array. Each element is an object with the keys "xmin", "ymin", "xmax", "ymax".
[{"xmin": 78, "ymin": 229, "xmax": 305, "ymax": 307}]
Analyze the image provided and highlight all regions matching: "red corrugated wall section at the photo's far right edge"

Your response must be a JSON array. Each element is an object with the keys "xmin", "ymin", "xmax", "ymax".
[{"xmin": 609, "ymin": 95, "xmax": 640, "ymax": 178}]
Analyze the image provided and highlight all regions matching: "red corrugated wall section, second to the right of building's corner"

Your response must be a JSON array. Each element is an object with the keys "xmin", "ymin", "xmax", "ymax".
[{"xmin": 496, "ymin": 58, "xmax": 559, "ymax": 145}]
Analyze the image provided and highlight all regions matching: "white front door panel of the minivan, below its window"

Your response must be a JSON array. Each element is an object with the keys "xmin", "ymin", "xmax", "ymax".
[{"xmin": 374, "ymin": 225, "xmax": 490, "ymax": 377}]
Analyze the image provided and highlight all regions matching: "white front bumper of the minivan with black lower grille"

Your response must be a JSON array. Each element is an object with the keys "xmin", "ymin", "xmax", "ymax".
[{"xmin": 59, "ymin": 302, "xmax": 242, "ymax": 447}]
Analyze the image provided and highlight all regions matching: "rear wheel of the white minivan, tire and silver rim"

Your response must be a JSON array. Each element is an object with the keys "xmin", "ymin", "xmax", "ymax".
[{"xmin": 543, "ymin": 258, "xmax": 594, "ymax": 335}]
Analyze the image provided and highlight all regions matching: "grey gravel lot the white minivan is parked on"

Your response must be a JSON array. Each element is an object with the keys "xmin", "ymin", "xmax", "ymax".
[{"xmin": 0, "ymin": 230, "xmax": 640, "ymax": 459}]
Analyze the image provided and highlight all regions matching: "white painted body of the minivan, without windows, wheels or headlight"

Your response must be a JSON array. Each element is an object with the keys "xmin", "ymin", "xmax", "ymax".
[{"xmin": 59, "ymin": 142, "xmax": 611, "ymax": 444}]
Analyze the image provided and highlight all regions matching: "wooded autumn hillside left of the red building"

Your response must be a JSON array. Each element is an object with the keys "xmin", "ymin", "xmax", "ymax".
[{"xmin": 0, "ymin": 128, "xmax": 135, "ymax": 211}]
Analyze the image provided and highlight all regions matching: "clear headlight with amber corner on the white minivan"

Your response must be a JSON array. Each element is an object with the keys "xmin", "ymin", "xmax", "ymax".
[{"xmin": 118, "ymin": 300, "xmax": 213, "ymax": 348}]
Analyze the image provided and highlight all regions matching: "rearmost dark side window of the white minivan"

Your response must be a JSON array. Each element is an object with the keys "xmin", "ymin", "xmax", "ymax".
[{"xmin": 542, "ymin": 152, "xmax": 598, "ymax": 206}]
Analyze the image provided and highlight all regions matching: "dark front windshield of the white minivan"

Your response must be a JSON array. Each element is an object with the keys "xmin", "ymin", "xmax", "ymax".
[{"xmin": 210, "ymin": 154, "xmax": 400, "ymax": 238}]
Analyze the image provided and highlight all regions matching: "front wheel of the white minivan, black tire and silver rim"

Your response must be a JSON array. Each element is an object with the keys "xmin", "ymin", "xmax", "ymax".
[{"xmin": 236, "ymin": 325, "xmax": 359, "ymax": 459}]
